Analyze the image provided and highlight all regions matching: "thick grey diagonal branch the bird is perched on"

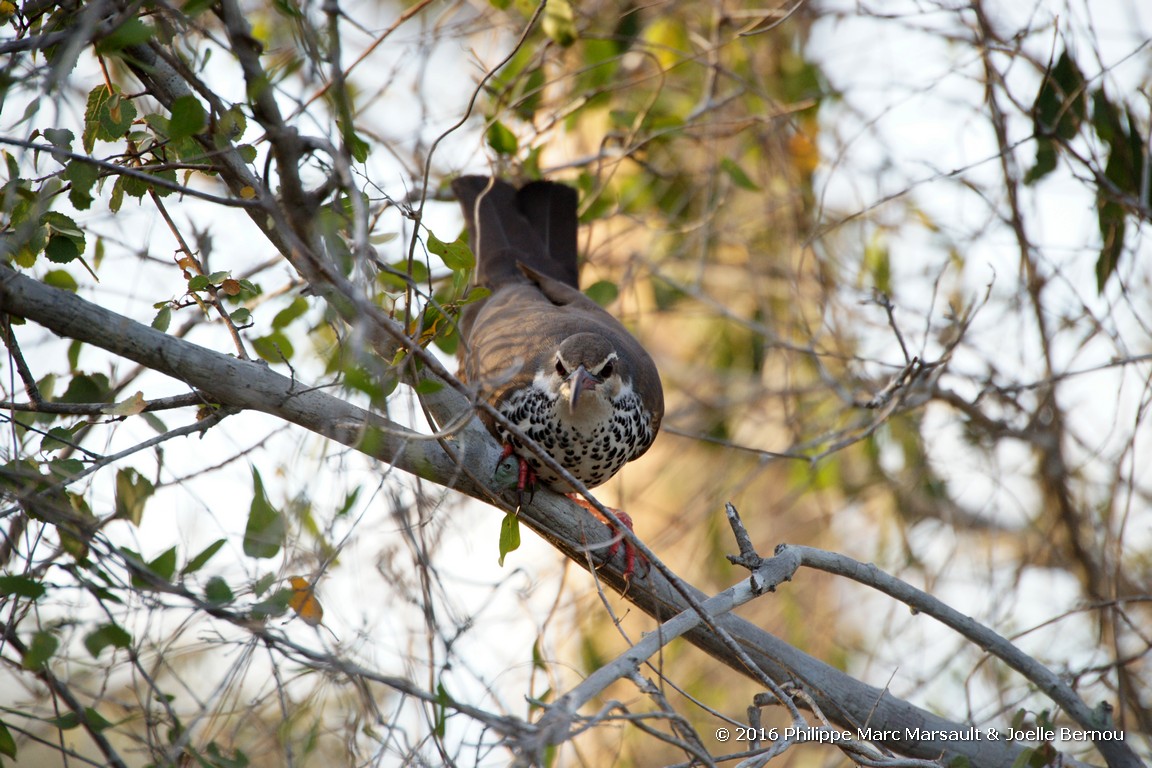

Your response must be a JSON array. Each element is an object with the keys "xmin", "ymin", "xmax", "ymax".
[{"xmin": 0, "ymin": 266, "xmax": 1115, "ymax": 768}]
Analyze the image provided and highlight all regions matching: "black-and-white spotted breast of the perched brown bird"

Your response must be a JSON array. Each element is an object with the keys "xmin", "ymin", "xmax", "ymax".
[{"xmin": 500, "ymin": 387, "xmax": 655, "ymax": 492}]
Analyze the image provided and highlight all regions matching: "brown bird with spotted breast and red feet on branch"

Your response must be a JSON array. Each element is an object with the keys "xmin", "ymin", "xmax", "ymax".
[{"xmin": 452, "ymin": 175, "xmax": 664, "ymax": 568}]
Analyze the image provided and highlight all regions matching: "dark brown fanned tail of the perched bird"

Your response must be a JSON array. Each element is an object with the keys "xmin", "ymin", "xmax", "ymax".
[{"xmin": 452, "ymin": 176, "xmax": 579, "ymax": 289}]
